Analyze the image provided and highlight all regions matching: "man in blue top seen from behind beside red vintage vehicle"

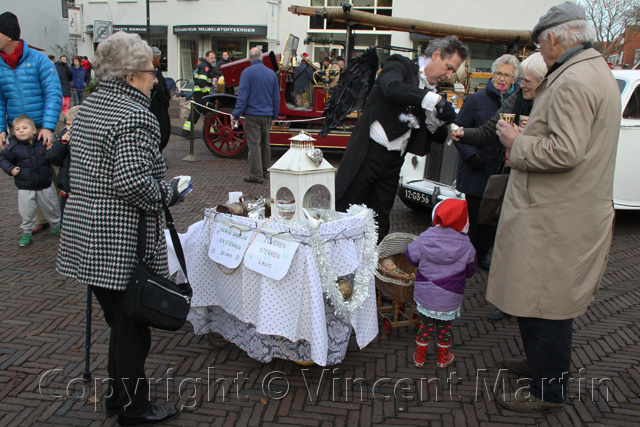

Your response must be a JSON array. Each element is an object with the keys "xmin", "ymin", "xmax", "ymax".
[{"xmin": 231, "ymin": 47, "xmax": 280, "ymax": 183}]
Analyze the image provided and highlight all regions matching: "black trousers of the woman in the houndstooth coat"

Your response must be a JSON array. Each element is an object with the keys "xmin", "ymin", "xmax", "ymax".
[{"xmin": 91, "ymin": 286, "xmax": 151, "ymax": 415}]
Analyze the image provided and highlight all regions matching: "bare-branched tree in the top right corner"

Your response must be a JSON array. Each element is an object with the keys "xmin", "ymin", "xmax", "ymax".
[{"xmin": 578, "ymin": 0, "xmax": 640, "ymax": 58}]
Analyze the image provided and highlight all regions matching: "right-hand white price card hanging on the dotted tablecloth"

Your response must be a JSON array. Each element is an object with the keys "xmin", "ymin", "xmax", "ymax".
[{"xmin": 244, "ymin": 233, "xmax": 300, "ymax": 280}]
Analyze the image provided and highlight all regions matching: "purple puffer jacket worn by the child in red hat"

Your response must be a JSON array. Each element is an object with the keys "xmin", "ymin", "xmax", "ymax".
[{"xmin": 405, "ymin": 227, "xmax": 477, "ymax": 311}]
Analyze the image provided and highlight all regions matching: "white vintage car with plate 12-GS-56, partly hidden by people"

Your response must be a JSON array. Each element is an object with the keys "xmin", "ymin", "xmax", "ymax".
[{"xmin": 398, "ymin": 70, "xmax": 640, "ymax": 210}]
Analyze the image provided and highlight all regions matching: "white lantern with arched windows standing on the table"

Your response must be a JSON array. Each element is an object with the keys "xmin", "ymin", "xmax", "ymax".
[{"xmin": 269, "ymin": 131, "xmax": 336, "ymax": 223}]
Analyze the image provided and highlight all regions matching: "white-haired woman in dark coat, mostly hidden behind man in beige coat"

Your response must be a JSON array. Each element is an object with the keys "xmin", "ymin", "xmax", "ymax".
[{"xmin": 451, "ymin": 52, "xmax": 547, "ymax": 322}]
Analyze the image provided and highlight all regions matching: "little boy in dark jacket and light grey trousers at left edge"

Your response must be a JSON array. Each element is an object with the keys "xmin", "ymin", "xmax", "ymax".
[{"xmin": 0, "ymin": 116, "xmax": 60, "ymax": 246}]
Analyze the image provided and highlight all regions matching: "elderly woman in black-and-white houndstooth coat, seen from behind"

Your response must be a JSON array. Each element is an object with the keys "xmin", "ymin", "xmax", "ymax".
[{"xmin": 57, "ymin": 32, "xmax": 181, "ymax": 425}]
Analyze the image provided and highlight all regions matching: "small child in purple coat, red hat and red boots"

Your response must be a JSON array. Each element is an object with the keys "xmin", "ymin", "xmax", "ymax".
[{"xmin": 405, "ymin": 199, "xmax": 477, "ymax": 368}]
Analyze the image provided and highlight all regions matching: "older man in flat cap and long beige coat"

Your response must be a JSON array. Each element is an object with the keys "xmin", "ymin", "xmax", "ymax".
[{"xmin": 486, "ymin": 2, "xmax": 621, "ymax": 412}]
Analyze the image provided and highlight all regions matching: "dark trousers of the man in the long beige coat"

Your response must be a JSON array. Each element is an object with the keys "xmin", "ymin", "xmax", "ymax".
[{"xmin": 518, "ymin": 317, "xmax": 573, "ymax": 403}]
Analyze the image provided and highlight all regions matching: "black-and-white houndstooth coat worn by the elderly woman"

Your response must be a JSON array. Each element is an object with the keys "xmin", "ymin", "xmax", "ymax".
[{"xmin": 57, "ymin": 80, "xmax": 173, "ymax": 291}]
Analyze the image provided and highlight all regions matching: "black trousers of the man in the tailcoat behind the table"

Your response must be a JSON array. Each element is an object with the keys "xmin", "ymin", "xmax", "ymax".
[{"xmin": 336, "ymin": 140, "xmax": 404, "ymax": 242}]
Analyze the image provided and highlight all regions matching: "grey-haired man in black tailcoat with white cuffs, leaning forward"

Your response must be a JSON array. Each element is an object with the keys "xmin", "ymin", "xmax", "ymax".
[{"xmin": 336, "ymin": 36, "xmax": 467, "ymax": 241}]
